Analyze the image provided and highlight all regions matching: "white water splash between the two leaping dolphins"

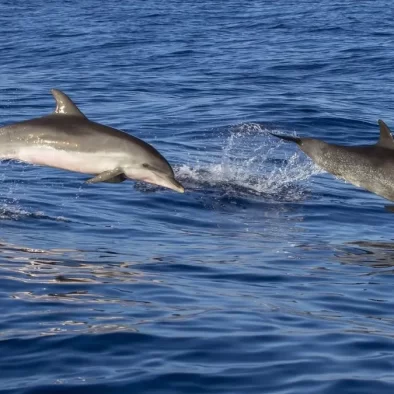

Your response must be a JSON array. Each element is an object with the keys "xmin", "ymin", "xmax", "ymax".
[{"xmin": 175, "ymin": 123, "xmax": 321, "ymax": 201}]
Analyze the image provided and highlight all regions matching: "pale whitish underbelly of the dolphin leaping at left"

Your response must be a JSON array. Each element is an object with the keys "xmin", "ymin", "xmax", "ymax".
[{"xmin": 14, "ymin": 146, "xmax": 125, "ymax": 174}]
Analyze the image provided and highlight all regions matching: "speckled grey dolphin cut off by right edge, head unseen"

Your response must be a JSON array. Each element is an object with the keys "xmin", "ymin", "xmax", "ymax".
[{"xmin": 271, "ymin": 120, "xmax": 394, "ymax": 201}]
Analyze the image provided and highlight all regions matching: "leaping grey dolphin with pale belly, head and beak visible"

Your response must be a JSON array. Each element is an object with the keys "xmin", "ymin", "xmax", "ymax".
[{"xmin": 0, "ymin": 89, "xmax": 184, "ymax": 193}]
